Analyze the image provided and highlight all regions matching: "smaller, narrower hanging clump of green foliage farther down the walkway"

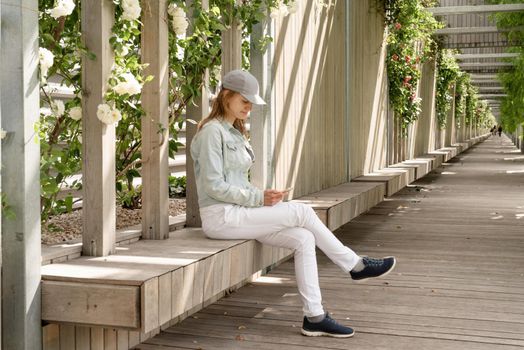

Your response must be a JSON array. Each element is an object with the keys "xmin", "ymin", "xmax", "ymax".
[{"xmin": 435, "ymin": 49, "xmax": 460, "ymax": 129}]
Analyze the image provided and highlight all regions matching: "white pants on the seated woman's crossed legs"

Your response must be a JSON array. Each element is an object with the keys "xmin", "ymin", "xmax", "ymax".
[{"xmin": 200, "ymin": 202, "xmax": 360, "ymax": 317}]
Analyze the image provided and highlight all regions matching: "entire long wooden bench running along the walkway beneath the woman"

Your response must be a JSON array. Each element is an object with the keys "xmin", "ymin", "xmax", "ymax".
[{"xmin": 42, "ymin": 137, "xmax": 492, "ymax": 348}]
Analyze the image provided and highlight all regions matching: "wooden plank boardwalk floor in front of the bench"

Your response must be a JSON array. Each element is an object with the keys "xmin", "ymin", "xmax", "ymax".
[{"xmin": 136, "ymin": 136, "xmax": 524, "ymax": 350}]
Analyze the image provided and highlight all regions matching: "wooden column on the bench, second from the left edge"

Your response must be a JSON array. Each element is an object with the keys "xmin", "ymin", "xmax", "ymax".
[{"xmin": 82, "ymin": 0, "xmax": 116, "ymax": 256}]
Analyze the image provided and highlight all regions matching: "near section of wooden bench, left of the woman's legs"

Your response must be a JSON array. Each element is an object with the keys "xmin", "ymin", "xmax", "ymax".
[{"xmin": 42, "ymin": 228, "xmax": 291, "ymax": 332}]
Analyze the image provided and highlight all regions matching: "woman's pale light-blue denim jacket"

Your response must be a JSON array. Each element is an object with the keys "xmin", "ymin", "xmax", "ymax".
[{"xmin": 191, "ymin": 120, "xmax": 264, "ymax": 208}]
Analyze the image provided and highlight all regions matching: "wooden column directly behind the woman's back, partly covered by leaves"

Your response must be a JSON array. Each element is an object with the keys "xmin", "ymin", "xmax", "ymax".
[{"xmin": 186, "ymin": 0, "xmax": 209, "ymax": 227}]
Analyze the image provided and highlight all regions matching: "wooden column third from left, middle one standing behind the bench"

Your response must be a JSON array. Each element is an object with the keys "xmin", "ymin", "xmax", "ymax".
[{"xmin": 142, "ymin": 0, "xmax": 169, "ymax": 239}]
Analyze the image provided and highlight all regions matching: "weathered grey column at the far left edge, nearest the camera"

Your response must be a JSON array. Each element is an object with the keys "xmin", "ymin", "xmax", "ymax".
[{"xmin": 0, "ymin": 0, "xmax": 42, "ymax": 350}]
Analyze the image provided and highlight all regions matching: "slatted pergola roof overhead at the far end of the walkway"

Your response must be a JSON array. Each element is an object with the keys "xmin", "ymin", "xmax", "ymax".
[{"xmin": 429, "ymin": 0, "xmax": 524, "ymax": 113}]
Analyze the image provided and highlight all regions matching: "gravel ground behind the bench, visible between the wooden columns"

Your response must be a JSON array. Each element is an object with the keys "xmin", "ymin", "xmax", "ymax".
[{"xmin": 42, "ymin": 198, "xmax": 186, "ymax": 244}]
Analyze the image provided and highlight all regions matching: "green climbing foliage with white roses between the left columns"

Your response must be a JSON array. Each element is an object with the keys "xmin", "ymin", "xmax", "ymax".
[{"xmin": 35, "ymin": 0, "xmax": 291, "ymax": 220}]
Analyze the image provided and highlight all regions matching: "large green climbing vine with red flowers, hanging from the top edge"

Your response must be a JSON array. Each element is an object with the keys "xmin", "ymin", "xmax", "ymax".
[{"xmin": 384, "ymin": 0, "xmax": 441, "ymax": 134}]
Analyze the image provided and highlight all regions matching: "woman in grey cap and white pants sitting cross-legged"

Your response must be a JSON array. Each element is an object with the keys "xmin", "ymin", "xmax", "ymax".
[{"xmin": 191, "ymin": 70, "xmax": 395, "ymax": 338}]
